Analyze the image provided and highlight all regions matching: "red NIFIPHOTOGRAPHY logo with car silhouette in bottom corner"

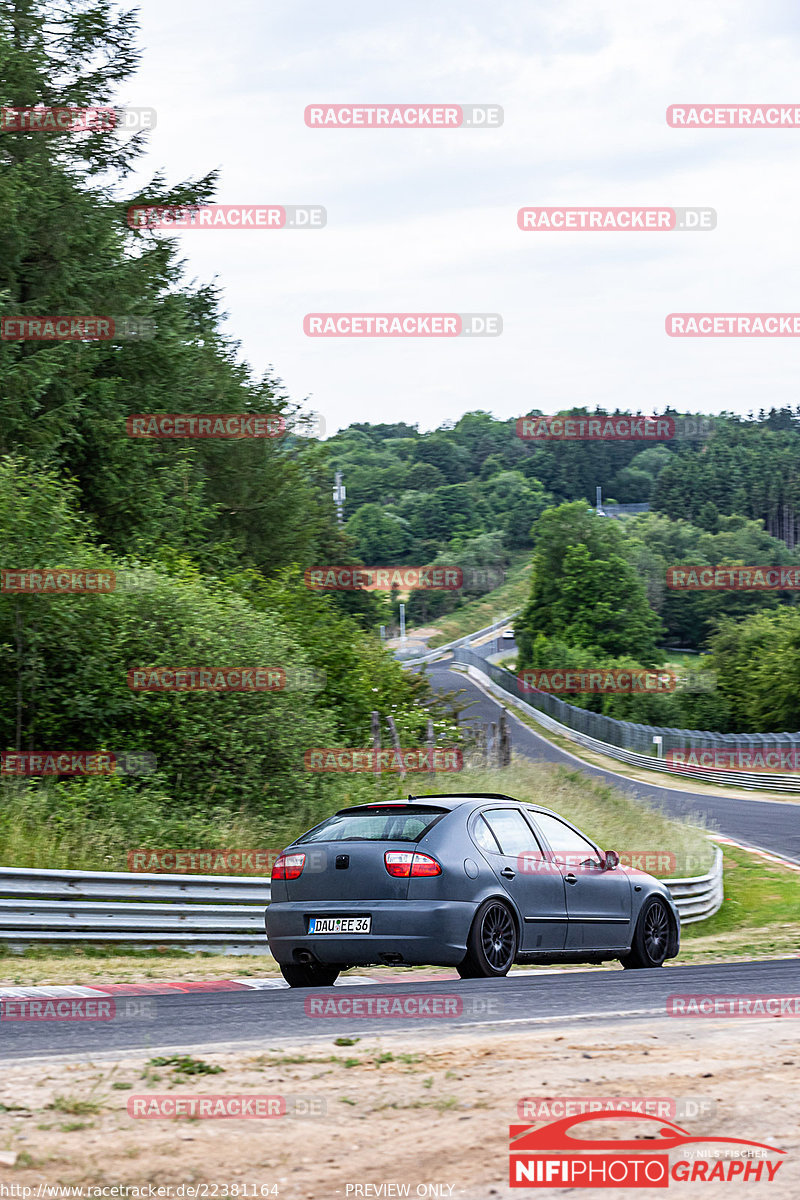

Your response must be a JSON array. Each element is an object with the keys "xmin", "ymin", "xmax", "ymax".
[{"xmin": 509, "ymin": 1109, "xmax": 786, "ymax": 1188}]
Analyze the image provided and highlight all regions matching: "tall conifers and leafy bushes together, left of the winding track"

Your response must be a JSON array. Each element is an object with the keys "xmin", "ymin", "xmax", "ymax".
[{"xmin": 0, "ymin": 0, "xmax": 441, "ymax": 839}]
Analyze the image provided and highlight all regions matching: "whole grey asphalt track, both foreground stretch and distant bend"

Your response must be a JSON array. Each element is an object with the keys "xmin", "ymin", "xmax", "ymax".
[{"xmin": 0, "ymin": 648, "xmax": 800, "ymax": 1061}]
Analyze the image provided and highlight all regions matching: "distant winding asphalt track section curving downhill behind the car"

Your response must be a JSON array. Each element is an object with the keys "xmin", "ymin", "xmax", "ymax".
[{"xmin": 427, "ymin": 662, "xmax": 800, "ymax": 864}]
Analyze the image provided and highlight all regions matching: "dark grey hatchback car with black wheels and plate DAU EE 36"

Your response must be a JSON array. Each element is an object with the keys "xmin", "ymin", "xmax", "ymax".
[{"xmin": 266, "ymin": 794, "xmax": 680, "ymax": 988}]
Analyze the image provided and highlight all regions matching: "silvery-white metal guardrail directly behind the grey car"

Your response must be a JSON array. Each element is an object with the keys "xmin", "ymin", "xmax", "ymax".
[{"xmin": 0, "ymin": 847, "xmax": 722, "ymax": 954}]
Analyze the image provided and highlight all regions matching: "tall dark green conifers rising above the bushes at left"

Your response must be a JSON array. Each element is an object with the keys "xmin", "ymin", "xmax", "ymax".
[{"xmin": 0, "ymin": 0, "xmax": 345, "ymax": 571}]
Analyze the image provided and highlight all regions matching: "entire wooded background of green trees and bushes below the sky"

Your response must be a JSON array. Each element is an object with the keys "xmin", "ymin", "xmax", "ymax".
[{"xmin": 0, "ymin": 0, "xmax": 800, "ymax": 864}]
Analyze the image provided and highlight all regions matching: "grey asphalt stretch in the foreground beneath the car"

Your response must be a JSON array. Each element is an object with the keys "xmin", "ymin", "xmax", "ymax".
[{"xmin": 0, "ymin": 958, "xmax": 800, "ymax": 1060}]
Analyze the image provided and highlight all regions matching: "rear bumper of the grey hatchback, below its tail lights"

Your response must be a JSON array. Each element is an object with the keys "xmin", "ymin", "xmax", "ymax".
[{"xmin": 265, "ymin": 900, "xmax": 475, "ymax": 966}]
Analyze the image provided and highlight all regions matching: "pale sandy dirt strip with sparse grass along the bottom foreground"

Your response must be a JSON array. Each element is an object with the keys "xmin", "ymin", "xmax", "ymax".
[{"xmin": 0, "ymin": 1019, "xmax": 800, "ymax": 1200}]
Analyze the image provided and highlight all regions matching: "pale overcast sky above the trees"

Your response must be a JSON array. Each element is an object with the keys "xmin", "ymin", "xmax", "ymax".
[{"xmin": 119, "ymin": 0, "xmax": 800, "ymax": 432}]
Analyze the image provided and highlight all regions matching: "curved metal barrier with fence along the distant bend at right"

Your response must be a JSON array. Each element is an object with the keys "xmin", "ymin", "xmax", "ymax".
[{"xmin": 453, "ymin": 646, "xmax": 800, "ymax": 792}]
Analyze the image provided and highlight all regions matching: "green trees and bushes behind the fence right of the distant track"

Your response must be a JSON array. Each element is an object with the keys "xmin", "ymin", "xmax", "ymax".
[{"xmin": 515, "ymin": 503, "xmax": 800, "ymax": 733}]
